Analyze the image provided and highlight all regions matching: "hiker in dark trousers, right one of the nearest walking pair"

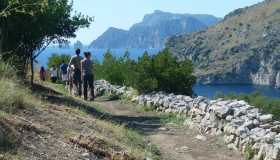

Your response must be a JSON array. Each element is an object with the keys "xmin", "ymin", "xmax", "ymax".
[{"xmin": 81, "ymin": 52, "xmax": 94, "ymax": 101}]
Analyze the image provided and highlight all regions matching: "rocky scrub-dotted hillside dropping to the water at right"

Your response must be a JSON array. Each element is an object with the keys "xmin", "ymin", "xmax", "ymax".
[{"xmin": 166, "ymin": 0, "xmax": 280, "ymax": 88}]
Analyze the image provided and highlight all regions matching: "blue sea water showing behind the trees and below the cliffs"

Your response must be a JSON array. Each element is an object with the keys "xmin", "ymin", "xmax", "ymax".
[{"xmin": 37, "ymin": 48, "xmax": 280, "ymax": 99}]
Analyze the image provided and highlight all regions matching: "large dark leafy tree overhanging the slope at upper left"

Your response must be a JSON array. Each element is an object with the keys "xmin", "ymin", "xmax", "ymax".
[{"xmin": 0, "ymin": 0, "xmax": 93, "ymax": 84}]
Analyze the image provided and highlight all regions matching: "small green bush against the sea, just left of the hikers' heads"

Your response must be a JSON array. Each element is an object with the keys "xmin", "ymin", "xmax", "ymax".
[{"xmin": 48, "ymin": 54, "xmax": 71, "ymax": 68}]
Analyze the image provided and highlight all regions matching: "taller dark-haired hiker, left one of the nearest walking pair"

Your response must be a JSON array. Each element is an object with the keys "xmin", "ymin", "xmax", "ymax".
[{"xmin": 68, "ymin": 49, "xmax": 82, "ymax": 96}]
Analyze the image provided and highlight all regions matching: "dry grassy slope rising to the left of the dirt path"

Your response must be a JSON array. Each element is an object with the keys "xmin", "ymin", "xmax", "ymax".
[{"xmin": 0, "ymin": 78, "xmax": 160, "ymax": 159}]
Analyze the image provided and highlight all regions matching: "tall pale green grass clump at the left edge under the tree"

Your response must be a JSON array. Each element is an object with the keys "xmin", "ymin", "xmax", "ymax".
[{"xmin": 0, "ymin": 62, "xmax": 36, "ymax": 154}]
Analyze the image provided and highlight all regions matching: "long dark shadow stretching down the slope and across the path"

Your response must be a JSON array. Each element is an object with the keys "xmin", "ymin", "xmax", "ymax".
[{"xmin": 38, "ymin": 84, "xmax": 161, "ymax": 134}]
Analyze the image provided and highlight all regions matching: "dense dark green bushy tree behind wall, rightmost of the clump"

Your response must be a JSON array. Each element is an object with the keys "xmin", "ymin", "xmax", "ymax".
[{"xmin": 153, "ymin": 49, "xmax": 196, "ymax": 95}]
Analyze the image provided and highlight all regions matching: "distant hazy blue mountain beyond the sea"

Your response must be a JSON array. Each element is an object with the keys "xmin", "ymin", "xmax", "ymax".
[{"xmin": 90, "ymin": 11, "xmax": 219, "ymax": 49}]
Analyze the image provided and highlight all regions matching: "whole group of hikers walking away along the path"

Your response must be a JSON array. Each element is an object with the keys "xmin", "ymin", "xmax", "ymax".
[{"xmin": 39, "ymin": 49, "xmax": 94, "ymax": 101}]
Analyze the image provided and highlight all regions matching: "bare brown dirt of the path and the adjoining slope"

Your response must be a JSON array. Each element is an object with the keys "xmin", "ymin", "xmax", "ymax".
[{"xmin": 0, "ymin": 84, "xmax": 243, "ymax": 160}]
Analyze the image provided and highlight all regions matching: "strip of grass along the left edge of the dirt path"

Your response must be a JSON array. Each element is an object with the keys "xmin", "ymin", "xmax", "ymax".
[{"xmin": 45, "ymin": 83, "xmax": 161, "ymax": 160}]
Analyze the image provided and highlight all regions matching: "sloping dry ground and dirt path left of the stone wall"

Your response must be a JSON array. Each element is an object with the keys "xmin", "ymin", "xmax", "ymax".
[{"xmin": 0, "ymin": 62, "xmax": 241, "ymax": 160}]
